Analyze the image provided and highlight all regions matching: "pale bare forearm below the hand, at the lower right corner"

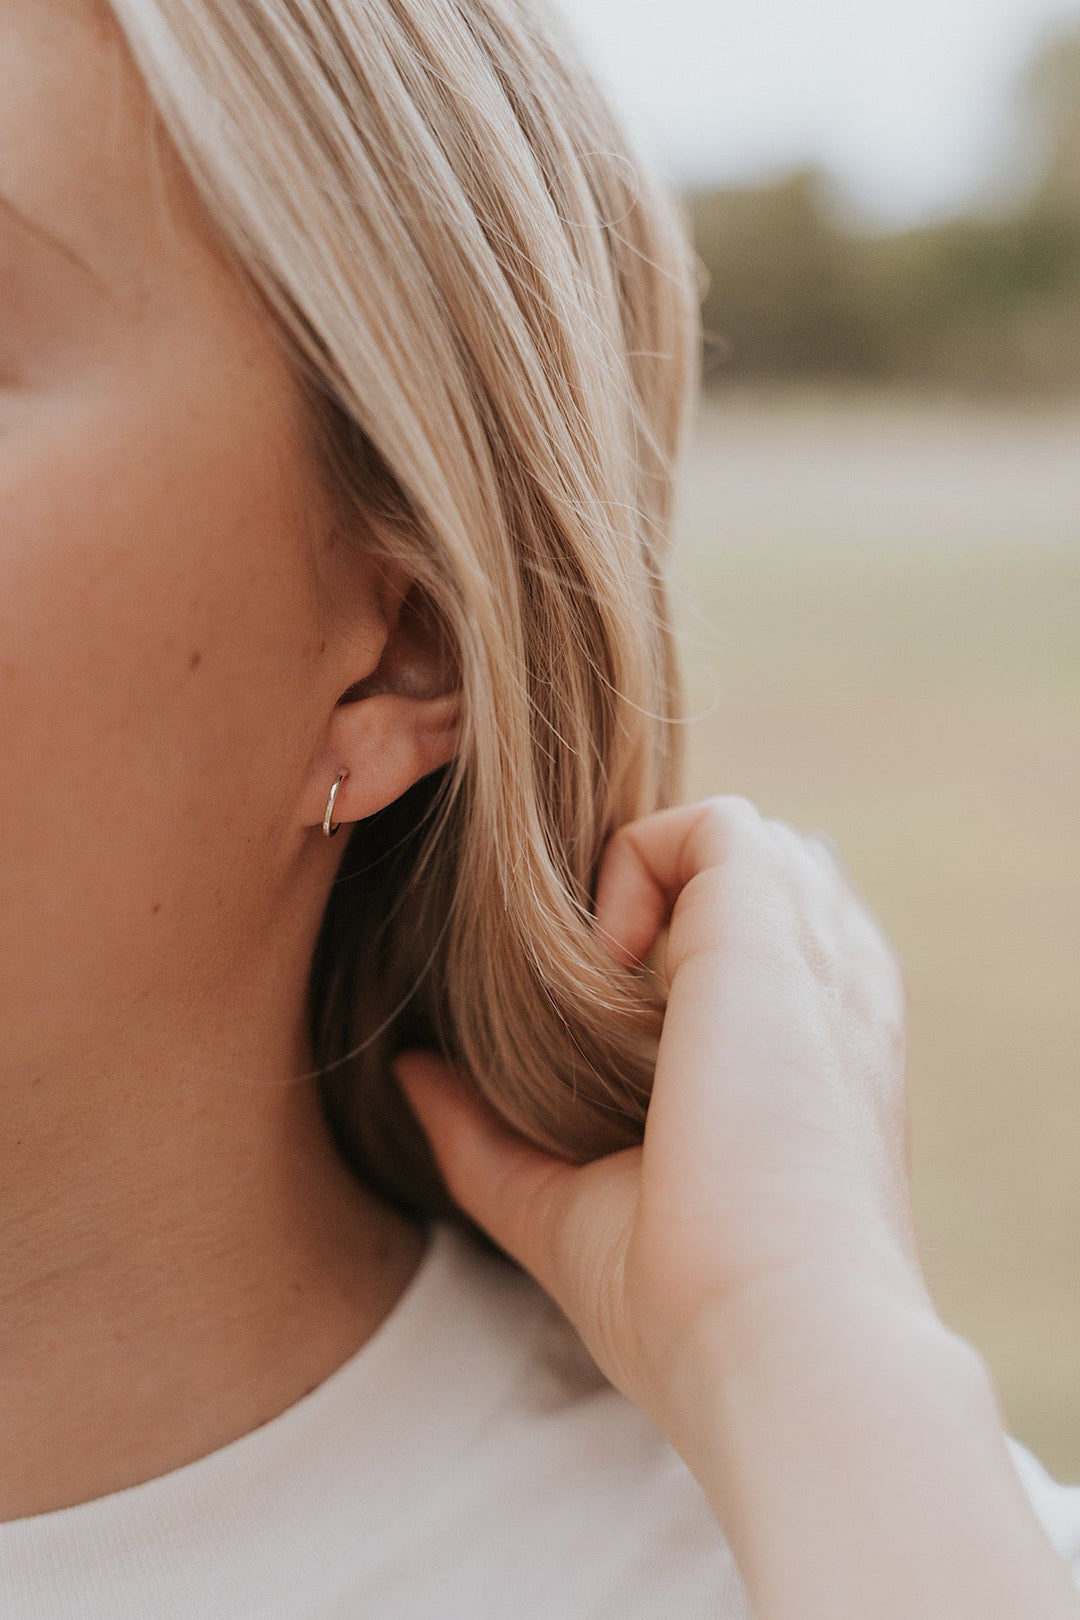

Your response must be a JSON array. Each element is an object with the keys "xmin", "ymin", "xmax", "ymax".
[{"xmin": 669, "ymin": 1291, "xmax": 1080, "ymax": 1620}]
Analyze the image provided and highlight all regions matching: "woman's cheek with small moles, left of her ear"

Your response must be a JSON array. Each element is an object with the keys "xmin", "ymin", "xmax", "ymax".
[{"xmin": 0, "ymin": 370, "xmax": 319, "ymax": 1000}]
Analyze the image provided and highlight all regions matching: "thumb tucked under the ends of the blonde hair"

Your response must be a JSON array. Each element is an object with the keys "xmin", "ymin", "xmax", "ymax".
[{"xmin": 393, "ymin": 1051, "xmax": 580, "ymax": 1304}]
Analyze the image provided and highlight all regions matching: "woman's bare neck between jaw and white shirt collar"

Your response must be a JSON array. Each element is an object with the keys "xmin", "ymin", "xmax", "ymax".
[{"xmin": 0, "ymin": 964, "xmax": 423, "ymax": 1520}]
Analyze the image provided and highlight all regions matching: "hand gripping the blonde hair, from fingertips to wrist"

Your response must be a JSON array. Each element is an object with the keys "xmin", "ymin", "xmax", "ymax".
[{"xmin": 397, "ymin": 799, "xmax": 931, "ymax": 1427}]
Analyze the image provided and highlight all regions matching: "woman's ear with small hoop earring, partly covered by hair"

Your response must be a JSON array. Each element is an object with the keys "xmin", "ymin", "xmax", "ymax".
[{"xmin": 303, "ymin": 585, "xmax": 460, "ymax": 826}]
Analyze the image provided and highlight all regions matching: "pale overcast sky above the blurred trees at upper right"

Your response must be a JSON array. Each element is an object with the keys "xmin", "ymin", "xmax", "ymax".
[{"xmin": 562, "ymin": 0, "xmax": 1080, "ymax": 224}]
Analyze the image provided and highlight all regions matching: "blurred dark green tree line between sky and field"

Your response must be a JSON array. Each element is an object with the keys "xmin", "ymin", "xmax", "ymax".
[{"xmin": 685, "ymin": 32, "xmax": 1080, "ymax": 395}]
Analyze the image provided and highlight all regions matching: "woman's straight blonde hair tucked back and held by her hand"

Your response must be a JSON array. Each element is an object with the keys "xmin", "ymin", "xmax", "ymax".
[{"xmin": 112, "ymin": 0, "xmax": 699, "ymax": 1213}]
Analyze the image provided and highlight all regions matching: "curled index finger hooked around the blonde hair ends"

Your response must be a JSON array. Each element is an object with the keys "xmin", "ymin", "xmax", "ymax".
[{"xmin": 596, "ymin": 797, "xmax": 764, "ymax": 966}]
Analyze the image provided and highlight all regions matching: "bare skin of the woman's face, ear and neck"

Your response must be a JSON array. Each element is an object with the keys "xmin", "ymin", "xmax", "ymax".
[{"xmin": 0, "ymin": 0, "xmax": 455, "ymax": 1520}]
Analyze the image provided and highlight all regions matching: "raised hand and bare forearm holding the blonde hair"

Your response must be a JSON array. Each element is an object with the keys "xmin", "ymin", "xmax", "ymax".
[{"xmin": 398, "ymin": 799, "xmax": 1080, "ymax": 1620}]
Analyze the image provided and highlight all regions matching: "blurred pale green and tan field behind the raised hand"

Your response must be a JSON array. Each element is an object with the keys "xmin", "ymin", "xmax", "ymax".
[{"xmin": 678, "ymin": 394, "xmax": 1080, "ymax": 1481}]
